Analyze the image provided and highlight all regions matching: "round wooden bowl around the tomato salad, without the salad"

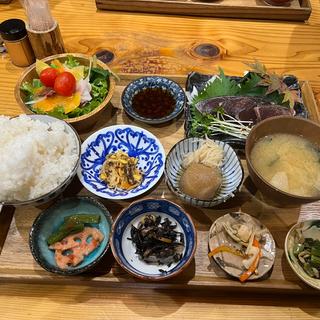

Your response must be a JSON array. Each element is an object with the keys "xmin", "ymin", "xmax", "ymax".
[{"xmin": 14, "ymin": 53, "xmax": 116, "ymax": 131}]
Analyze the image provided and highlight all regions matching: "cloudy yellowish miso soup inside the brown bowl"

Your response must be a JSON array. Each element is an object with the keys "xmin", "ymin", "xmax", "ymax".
[{"xmin": 250, "ymin": 133, "xmax": 320, "ymax": 197}]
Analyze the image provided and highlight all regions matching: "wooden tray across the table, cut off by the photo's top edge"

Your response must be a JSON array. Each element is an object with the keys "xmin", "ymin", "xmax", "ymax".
[{"xmin": 96, "ymin": 0, "xmax": 311, "ymax": 21}]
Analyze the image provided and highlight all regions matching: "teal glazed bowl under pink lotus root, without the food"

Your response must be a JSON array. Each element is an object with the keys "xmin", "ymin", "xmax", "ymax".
[{"xmin": 29, "ymin": 197, "xmax": 112, "ymax": 275}]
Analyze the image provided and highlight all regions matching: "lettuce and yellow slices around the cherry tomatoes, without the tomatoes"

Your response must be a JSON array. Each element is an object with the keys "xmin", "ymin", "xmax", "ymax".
[{"xmin": 20, "ymin": 55, "xmax": 111, "ymax": 119}]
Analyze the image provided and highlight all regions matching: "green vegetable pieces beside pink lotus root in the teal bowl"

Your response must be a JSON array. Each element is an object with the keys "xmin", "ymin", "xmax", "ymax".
[{"xmin": 47, "ymin": 214, "xmax": 100, "ymax": 246}]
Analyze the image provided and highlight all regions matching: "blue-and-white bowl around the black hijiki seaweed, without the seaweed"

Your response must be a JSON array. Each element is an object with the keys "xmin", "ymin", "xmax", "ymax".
[{"xmin": 111, "ymin": 199, "xmax": 197, "ymax": 281}]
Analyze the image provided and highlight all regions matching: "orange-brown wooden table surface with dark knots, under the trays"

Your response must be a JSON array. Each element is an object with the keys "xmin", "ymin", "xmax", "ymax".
[{"xmin": 0, "ymin": 0, "xmax": 320, "ymax": 320}]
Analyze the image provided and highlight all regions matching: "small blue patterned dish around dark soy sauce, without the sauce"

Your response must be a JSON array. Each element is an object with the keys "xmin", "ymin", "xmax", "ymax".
[{"xmin": 121, "ymin": 76, "xmax": 186, "ymax": 124}]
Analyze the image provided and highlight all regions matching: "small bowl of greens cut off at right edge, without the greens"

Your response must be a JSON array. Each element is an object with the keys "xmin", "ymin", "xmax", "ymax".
[{"xmin": 284, "ymin": 220, "xmax": 320, "ymax": 290}]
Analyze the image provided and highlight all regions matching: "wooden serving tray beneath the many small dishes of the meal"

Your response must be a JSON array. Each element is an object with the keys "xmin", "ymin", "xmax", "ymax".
[{"xmin": 0, "ymin": 75, "xmax": 320, "ymax": 294}]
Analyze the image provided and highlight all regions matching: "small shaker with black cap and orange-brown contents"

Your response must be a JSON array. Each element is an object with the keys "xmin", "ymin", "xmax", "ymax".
[{"xmin": 0, "ymin": 19, "xmax": 35, "ymax": 67}]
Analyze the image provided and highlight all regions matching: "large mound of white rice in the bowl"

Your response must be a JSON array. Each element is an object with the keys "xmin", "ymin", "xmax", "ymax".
[{"xmin": 0, "ymin": 115, "xmax": 78, "ymax": 201}]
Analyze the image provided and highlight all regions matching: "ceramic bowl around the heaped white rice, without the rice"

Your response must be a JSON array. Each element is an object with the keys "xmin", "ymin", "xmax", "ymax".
[{"xmin": 0, "ymin": 114, "xmax": 81, "ymax": 207}]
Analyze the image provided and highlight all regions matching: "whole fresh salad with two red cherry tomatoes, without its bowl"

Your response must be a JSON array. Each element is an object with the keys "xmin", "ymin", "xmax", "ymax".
[{"xmin": 20, "ymin": 55, "xmax": 110, "ymax": 119}]
